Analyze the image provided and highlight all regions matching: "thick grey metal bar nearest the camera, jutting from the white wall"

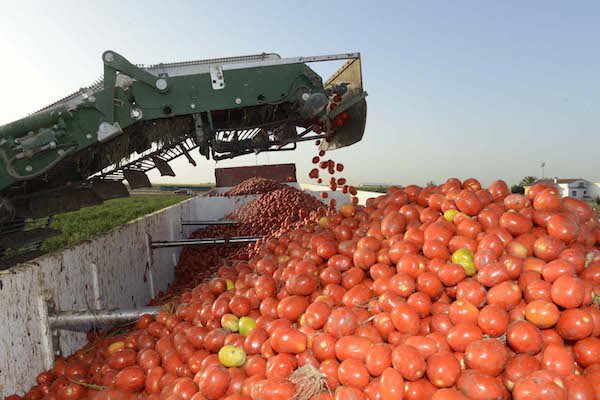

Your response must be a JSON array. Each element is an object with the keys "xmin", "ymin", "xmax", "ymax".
[{"xmin": 48, "ymin": 307, "xmax": 160, "ymax": 329}]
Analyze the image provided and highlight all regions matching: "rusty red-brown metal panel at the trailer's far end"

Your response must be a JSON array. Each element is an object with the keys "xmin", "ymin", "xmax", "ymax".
[{"xmin": 215, "ymin": 164, "xmax": 297, "ymax": 187}]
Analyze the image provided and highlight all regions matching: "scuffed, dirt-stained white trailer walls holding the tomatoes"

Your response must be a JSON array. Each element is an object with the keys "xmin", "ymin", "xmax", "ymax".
[{"xmin": 0, "ymin": 183, "xmax": 378, "ymax": 396}]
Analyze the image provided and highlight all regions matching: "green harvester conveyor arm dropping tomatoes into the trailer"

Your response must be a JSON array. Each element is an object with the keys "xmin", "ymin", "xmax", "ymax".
[{"xmin": 0, "ymin": 51, "xmax": 367, "ymax": 249}]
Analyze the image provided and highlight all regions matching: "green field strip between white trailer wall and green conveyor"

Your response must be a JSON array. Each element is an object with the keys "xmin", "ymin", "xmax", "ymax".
[{"xmin": 42, "ymin": 195, "xmax": 189, "ymax": 251}]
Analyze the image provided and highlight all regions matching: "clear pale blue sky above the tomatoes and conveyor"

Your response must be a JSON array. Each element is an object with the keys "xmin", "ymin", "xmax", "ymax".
[{"xmin": 0, "ymin": 0, "xmax": 600, "ymax": 188}]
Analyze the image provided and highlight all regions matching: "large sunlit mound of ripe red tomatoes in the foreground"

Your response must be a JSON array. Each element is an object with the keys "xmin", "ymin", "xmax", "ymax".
[{"xmin": 9, "ymin": 179, "xmax": 600, "ymax": 400}]
